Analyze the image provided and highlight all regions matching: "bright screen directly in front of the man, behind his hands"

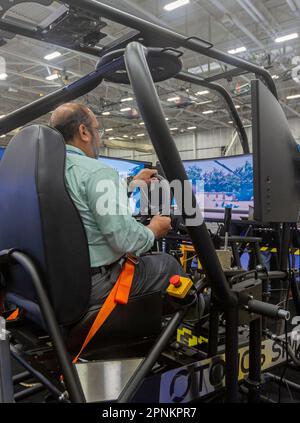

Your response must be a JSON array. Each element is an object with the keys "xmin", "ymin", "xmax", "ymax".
[{"xmin": 99, "ymin": 156, "xmax": 152, "ymax": 215}]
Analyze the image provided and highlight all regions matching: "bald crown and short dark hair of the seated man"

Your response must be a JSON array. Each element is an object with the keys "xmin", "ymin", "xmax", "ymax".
[{"xmin": 50, "ymin": 103, "xmax": 95, "ymax": 143}]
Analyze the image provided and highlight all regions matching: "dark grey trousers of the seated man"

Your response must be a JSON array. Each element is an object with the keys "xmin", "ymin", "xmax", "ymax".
[{"xmin": 90, "ymin": 253, "xmax": 186, "ymax": 312}]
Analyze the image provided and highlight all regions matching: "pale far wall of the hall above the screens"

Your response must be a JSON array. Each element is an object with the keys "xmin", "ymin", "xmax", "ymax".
[{"xmin": 105, "ymin": 118, "xmax": 300, "ymax": 163}]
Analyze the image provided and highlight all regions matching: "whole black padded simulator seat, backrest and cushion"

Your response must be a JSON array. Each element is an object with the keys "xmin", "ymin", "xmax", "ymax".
[{"xmin": 0, "ymin": 125, "xmax": 161, "ymax": 351}]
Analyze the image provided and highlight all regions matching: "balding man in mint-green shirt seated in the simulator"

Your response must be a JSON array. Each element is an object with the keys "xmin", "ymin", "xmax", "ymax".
[{"xmin": 50, "ymin": 103, "xmax": 184, "ymax": 312}]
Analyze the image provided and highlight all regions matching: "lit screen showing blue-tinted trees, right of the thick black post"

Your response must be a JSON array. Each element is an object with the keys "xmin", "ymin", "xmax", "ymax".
[{"xmin": 183, "ymin": 154, "xmax": 254, "ymax": 220}]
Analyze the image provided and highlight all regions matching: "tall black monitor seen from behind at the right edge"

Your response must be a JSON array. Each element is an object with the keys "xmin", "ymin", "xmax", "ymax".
[{"xmin": 251, "ymin": 80, "xmax": 300, "ymax": 223}]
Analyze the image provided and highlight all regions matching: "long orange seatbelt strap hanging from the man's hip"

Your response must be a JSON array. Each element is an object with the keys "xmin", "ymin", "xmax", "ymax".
[{"xmin": 73, "ymin": 259, "xmax": 135, "ymax": 364}]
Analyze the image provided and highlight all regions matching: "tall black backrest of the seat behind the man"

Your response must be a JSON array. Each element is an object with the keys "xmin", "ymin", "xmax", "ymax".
[{"xmin": 0, "ymin": 125, "xmax": 91, "ymax": 325}]
